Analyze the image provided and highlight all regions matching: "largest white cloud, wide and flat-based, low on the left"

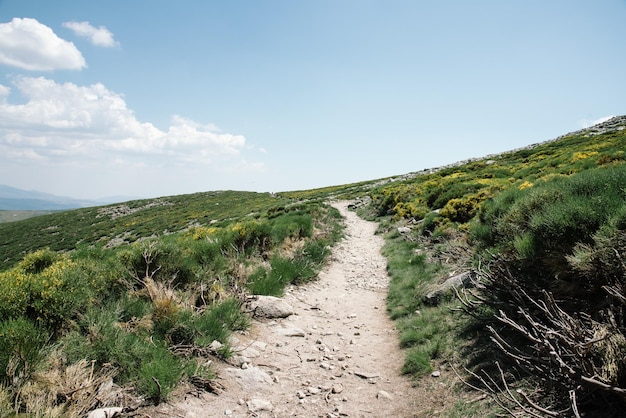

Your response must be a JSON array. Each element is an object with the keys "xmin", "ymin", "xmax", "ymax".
[{"xmin": 0, "ymin": 76, "xmax": 259, "ymax": 170}]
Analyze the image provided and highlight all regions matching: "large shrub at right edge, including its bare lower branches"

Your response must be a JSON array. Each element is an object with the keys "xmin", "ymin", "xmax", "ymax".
[{"xmin": 473, "ymin": 162, "xmax": 626, "ymax": 414}]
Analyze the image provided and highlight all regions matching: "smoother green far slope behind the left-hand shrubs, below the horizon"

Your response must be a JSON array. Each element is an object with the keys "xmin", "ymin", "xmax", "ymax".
[{"xmin": 0, "ymin": 191, "xmax": 290, "ymax": 270}]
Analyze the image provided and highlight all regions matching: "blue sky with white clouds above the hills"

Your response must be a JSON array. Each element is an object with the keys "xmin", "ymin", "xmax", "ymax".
[{"xmin": 0, "ymin": 0, "xmax": 626, "ymax": 199}]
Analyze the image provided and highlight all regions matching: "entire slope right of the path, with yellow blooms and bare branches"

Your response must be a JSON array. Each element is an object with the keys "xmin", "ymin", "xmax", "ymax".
[{"xmin": 362, "ymin": 118, "xmax": 626, "ymax": 416}]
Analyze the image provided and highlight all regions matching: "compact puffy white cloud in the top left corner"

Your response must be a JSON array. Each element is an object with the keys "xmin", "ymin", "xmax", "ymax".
[{"xmin": 0, "ymin": 17, "xmax": 86, "ymax": 71}]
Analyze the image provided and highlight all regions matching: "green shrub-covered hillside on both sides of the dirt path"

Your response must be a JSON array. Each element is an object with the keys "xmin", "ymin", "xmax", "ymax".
[{"xmin": 0, "ymin": 117, "xmax": 626, "ymax": 416}]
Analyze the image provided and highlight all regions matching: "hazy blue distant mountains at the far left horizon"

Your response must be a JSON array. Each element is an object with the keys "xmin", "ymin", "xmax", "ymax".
[{"xmin": 0, "ymin": 184, "xmax": 132, "ymax": 210}]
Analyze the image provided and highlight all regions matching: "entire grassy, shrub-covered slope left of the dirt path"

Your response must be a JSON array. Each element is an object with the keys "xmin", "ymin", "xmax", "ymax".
[{"xmin": 0, "ymin": 192, "xmax": 341, "ymax": 416}]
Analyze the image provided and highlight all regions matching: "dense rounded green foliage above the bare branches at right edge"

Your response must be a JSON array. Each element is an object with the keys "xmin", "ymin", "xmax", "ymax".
[{"xmin": 472, "ymin": 166, "xmax": 626, "ymax": 265}]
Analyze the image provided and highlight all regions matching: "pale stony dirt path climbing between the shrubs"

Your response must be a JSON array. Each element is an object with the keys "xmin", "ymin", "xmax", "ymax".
[{"xmin": 144, "ymin": 202, "xmax": 416, "ymax": 418}]
